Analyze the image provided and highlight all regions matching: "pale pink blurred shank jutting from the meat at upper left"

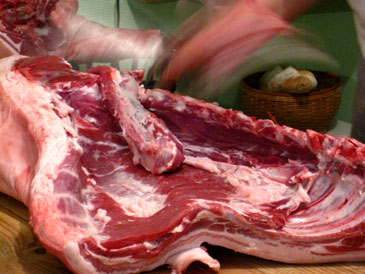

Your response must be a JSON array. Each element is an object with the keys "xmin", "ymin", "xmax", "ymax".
[{"xmin": 55, "ymin": 15, "xmax": 162, "ymax": 63}]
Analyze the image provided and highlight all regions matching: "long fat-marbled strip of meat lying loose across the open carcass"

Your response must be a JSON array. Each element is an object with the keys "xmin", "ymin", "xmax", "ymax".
[{"xmin": 89, "ymin": 67, "xmax": 184, "ymax": 174}]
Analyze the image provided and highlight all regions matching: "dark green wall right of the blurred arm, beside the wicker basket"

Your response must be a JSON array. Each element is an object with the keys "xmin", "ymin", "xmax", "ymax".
[{"xmin": 294, "ymin": 0, "xmax": 360, "ymax": 122}]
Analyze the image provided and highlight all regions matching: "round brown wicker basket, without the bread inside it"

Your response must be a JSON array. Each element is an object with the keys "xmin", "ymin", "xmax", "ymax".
[{"xmin": 241, "ymin": 71, "xmax": 342, "ymax": 133}]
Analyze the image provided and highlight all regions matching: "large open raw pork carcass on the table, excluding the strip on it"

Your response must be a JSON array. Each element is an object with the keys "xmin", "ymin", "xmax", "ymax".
[{"xmin": 0, "ymin": 56, "xmax": 365, "ymax": 273}]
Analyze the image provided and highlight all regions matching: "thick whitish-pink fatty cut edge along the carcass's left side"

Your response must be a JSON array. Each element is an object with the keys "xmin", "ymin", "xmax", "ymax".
[{"xmin": 0, "ymin": 56, "xmax": 82, "ymax": 259}]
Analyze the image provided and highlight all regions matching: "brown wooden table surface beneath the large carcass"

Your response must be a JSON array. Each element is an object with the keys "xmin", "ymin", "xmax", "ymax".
[{"xmin": 0, "ymin": 193, "xmax": 365, "ymax": 274}]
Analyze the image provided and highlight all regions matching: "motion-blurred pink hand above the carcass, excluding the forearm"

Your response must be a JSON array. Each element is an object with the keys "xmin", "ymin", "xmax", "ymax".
[{"xmin": 154, "ymin": 0, "xmax": 294, "ymax": 93}]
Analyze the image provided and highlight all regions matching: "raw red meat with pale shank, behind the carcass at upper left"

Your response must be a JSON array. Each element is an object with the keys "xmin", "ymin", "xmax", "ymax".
[{"xmin": 0, "ymin": 0, "xmax": 161, "ymax": 63}]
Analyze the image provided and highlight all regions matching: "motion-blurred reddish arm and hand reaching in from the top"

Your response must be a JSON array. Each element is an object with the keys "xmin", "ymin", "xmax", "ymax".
[{"xmin": 159, "ymin": 0, "xmax": 320, "ymax": 92}]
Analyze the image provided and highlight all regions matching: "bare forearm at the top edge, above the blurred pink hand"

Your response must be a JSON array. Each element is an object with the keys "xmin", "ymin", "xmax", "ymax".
[{"xmin": 257, "ymin": 0, "xmax": 321, "ymax": 21}]
